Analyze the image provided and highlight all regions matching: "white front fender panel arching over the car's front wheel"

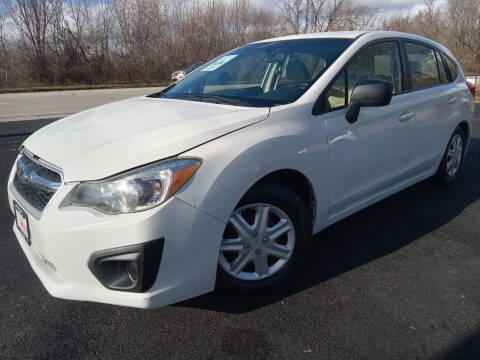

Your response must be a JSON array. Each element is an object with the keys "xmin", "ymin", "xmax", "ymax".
[{"xmin": 176, "ymin": 105, "xmax": 328, "ymax": 232}]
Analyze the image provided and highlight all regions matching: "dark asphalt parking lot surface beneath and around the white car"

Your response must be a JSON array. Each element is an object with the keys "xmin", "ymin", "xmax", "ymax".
[{"xmin": 0, "ymin": 105, "xmax": 480, "ymax": 359}]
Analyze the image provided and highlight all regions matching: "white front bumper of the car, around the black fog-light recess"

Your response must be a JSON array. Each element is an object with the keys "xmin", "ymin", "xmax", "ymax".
[{"xmin": 8, "ymin": 160, "xmax": 225, "ymax": 308}]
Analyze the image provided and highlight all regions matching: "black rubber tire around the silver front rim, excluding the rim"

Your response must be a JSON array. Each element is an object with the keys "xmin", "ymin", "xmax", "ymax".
[{"xmin": 217, "ymin": 185, "xmax": 312, "ymax": 291}]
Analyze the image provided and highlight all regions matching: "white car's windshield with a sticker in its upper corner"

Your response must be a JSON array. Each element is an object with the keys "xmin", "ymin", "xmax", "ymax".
[{"xmin": 151, "ymin": 39, "xmax": 353, "ymax": 107}]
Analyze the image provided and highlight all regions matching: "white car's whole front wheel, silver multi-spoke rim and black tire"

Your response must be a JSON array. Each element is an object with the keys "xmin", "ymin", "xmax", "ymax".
[{"xmin": 217, "ymin": 185, "xmax": 312, "ymax": 290}]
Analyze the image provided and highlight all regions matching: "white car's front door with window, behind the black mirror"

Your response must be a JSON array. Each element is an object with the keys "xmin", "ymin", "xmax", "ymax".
[{"xmin": 322, "ymin": 41, "xmax": 415, "ymax": 221}]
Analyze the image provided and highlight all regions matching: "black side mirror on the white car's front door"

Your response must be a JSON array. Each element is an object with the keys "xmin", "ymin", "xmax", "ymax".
[{"xmin": 345, "ymin": 80, "xmax": 393, "ymax": 124}]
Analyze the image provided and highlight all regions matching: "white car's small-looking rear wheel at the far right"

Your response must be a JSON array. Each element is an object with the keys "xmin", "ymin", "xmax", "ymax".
[{"xmin": 435, "ymin": 126, "xmax": 466, "ymax": 185}]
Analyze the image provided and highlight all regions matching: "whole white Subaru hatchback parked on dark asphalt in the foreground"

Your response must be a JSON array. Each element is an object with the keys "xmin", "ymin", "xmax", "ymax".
[{"xmin": 8, "ymin": 32, "xmax": 474, "ymax": 308}]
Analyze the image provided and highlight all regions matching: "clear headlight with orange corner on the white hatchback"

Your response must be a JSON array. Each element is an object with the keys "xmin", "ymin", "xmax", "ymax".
[{"xmin": 72, "ymin": 158, "xmax": 201, "ymax": 215}]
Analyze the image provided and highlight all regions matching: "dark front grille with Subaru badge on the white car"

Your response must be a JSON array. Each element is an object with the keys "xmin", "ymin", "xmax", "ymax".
[{"xmin": 13, "ymin": 154, "xmax": 62, "ymax": 212}]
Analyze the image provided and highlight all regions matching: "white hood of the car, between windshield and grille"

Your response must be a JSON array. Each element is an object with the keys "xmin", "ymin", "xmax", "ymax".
[{"xmin": 24, "ymin": 97, "xmax": 269, "ymax": 182}]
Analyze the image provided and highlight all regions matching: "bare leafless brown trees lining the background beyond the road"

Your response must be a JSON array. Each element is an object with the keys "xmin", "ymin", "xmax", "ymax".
[{"xmin": 0, "ymin": 0, "xmax": 480, "ymax": 87}]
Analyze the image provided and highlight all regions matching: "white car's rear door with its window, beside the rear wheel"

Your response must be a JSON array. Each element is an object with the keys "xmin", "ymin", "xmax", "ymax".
[{"xmin": 404, "ymin": 41, "xmax": 456, "ymax": 176}]
